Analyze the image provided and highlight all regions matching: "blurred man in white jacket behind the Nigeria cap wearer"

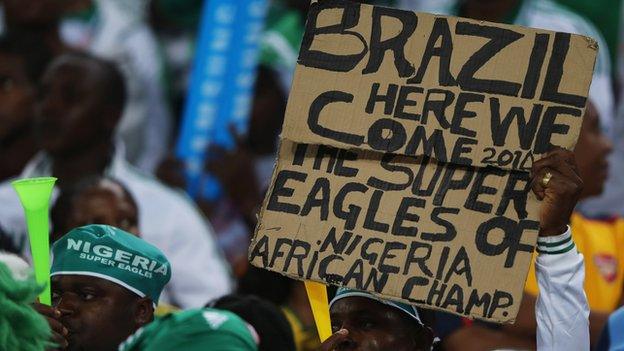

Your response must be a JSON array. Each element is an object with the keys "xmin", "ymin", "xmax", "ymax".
[{"xmin": 0, "ymin": 54, "xmax": 232, "ymax": 308}]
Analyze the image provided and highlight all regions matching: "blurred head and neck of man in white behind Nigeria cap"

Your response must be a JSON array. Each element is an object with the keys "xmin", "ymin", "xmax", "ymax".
[{"xmin": 36, "ymin": 55, "xmax": 122, "ymax": 187}]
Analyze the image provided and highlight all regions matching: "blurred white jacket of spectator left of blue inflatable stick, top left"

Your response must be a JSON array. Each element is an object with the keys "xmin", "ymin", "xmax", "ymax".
[{"xmin": 57, "ymin": 0, "xmax": 172, "ymax": 173}]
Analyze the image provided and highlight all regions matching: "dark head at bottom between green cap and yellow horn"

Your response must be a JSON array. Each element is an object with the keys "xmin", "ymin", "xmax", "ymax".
[{"xmin": 206, "ymin": 295, "xmax": 295, "ymax": 351}]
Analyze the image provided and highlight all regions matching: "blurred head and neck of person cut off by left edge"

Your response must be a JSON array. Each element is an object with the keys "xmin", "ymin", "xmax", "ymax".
[{"xmin": 0, "ymin": 53, "xmax": 37, "ymax": 180}]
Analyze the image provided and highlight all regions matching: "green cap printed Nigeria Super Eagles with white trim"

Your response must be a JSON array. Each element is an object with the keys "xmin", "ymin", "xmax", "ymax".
[{"xmin": 50, "ymin": 224, "xmax": 171, "ymax": 303}]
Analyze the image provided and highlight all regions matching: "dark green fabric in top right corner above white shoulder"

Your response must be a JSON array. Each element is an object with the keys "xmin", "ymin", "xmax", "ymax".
[{"xmin": 557, "ymin": 0, "xmax": 622, "ymax": 69}]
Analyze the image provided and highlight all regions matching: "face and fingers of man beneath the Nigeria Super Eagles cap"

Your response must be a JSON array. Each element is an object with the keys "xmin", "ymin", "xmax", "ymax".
[{"xmin": 35, "ymin": 275, "xmax": 154, "ymax": 351}]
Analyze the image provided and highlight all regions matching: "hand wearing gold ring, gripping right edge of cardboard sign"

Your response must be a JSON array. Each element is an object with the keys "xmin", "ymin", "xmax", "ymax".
[{"xmin": 531, "ymin": 149, "xmax": 583, "ymax": 236}]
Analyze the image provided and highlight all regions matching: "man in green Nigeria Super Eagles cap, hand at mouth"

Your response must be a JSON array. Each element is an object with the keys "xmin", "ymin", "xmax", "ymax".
[{"xmin": 35, "ymin": 224, "xmax": 171, "ymax": 351}]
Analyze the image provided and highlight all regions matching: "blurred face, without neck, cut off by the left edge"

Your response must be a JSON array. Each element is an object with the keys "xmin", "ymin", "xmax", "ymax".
[{"xmin": 0, "ymin": 53, "xmax": 34, "ymax": 143}]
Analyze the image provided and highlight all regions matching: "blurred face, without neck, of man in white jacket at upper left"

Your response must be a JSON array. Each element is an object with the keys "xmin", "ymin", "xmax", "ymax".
[{"xmin": 37, "ymin": 57, "xmax": 109, "ymax": 155}]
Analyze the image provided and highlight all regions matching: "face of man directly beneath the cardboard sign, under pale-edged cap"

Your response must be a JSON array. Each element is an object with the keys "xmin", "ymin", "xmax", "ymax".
[{"xmin": 330, "ymin": 297, "xmax": 430, "ymax": 351}]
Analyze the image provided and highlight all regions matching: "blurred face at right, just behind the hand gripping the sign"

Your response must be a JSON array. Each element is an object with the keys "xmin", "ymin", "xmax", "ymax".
[{"xmin": 574, "ymin": 102, "xmax": 613, "ymax": 198}]
